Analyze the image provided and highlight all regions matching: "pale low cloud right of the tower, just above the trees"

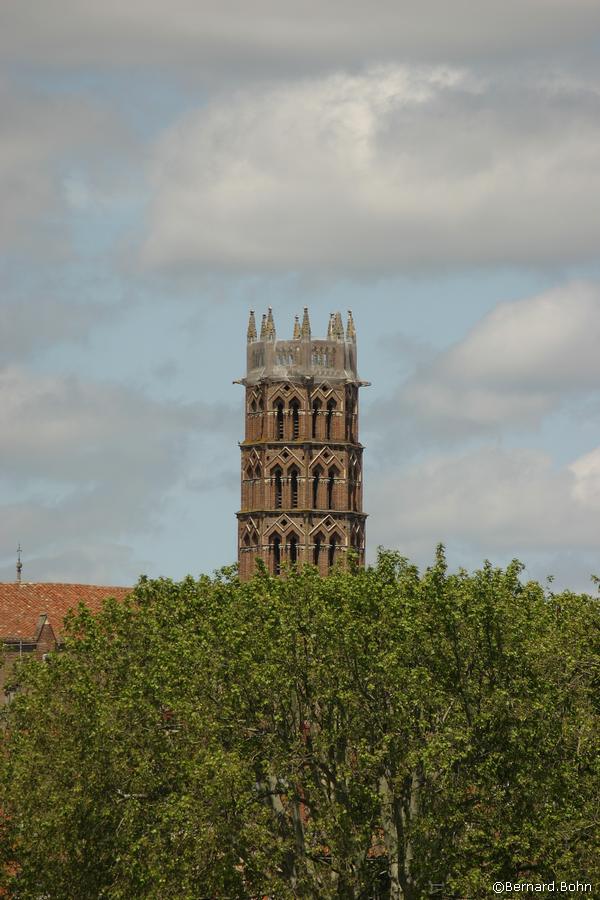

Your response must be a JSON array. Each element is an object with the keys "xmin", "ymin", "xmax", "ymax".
[{"xmin": 368, "ymin": 447, "xmax": 600, "ymax": 560}]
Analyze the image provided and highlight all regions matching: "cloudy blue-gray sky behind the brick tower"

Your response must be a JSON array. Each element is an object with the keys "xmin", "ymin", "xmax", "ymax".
[{"xmin": 0, "ymin": 0, "xmax": 600, "ymax": 591}]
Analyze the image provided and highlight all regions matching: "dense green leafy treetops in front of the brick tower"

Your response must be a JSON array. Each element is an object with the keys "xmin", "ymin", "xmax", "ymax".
[{"xmin": 0, "ymin": 548, "xmax": 600, "ymax": 900}]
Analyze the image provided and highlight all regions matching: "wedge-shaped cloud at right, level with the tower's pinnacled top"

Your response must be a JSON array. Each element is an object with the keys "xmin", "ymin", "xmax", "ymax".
[{"xmin": 370, "ymin": 283, "xmax": 600, "ymax": 439}]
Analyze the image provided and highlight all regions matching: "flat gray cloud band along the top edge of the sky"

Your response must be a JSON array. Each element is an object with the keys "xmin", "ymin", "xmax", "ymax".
[{"xmin": 0, "ymin": 0, "xmax": 600, "ymax": 71}]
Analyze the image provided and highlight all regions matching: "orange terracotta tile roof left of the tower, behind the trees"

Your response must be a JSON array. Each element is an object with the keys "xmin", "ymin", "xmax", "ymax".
[{"xmin": 0, "ymin": 582, "xmax": 131, "ymax": 640}]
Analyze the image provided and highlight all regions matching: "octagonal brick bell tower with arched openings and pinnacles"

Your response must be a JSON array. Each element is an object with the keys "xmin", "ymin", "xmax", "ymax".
[{"xmin": 237, "ymin": 307, "xmax": 368, "ymax": 580}]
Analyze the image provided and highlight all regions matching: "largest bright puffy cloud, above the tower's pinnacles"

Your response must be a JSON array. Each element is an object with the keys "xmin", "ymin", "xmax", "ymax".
[{"xmin": 143, "ymin": 66, "xmax": 600, "ymax": 274}]
